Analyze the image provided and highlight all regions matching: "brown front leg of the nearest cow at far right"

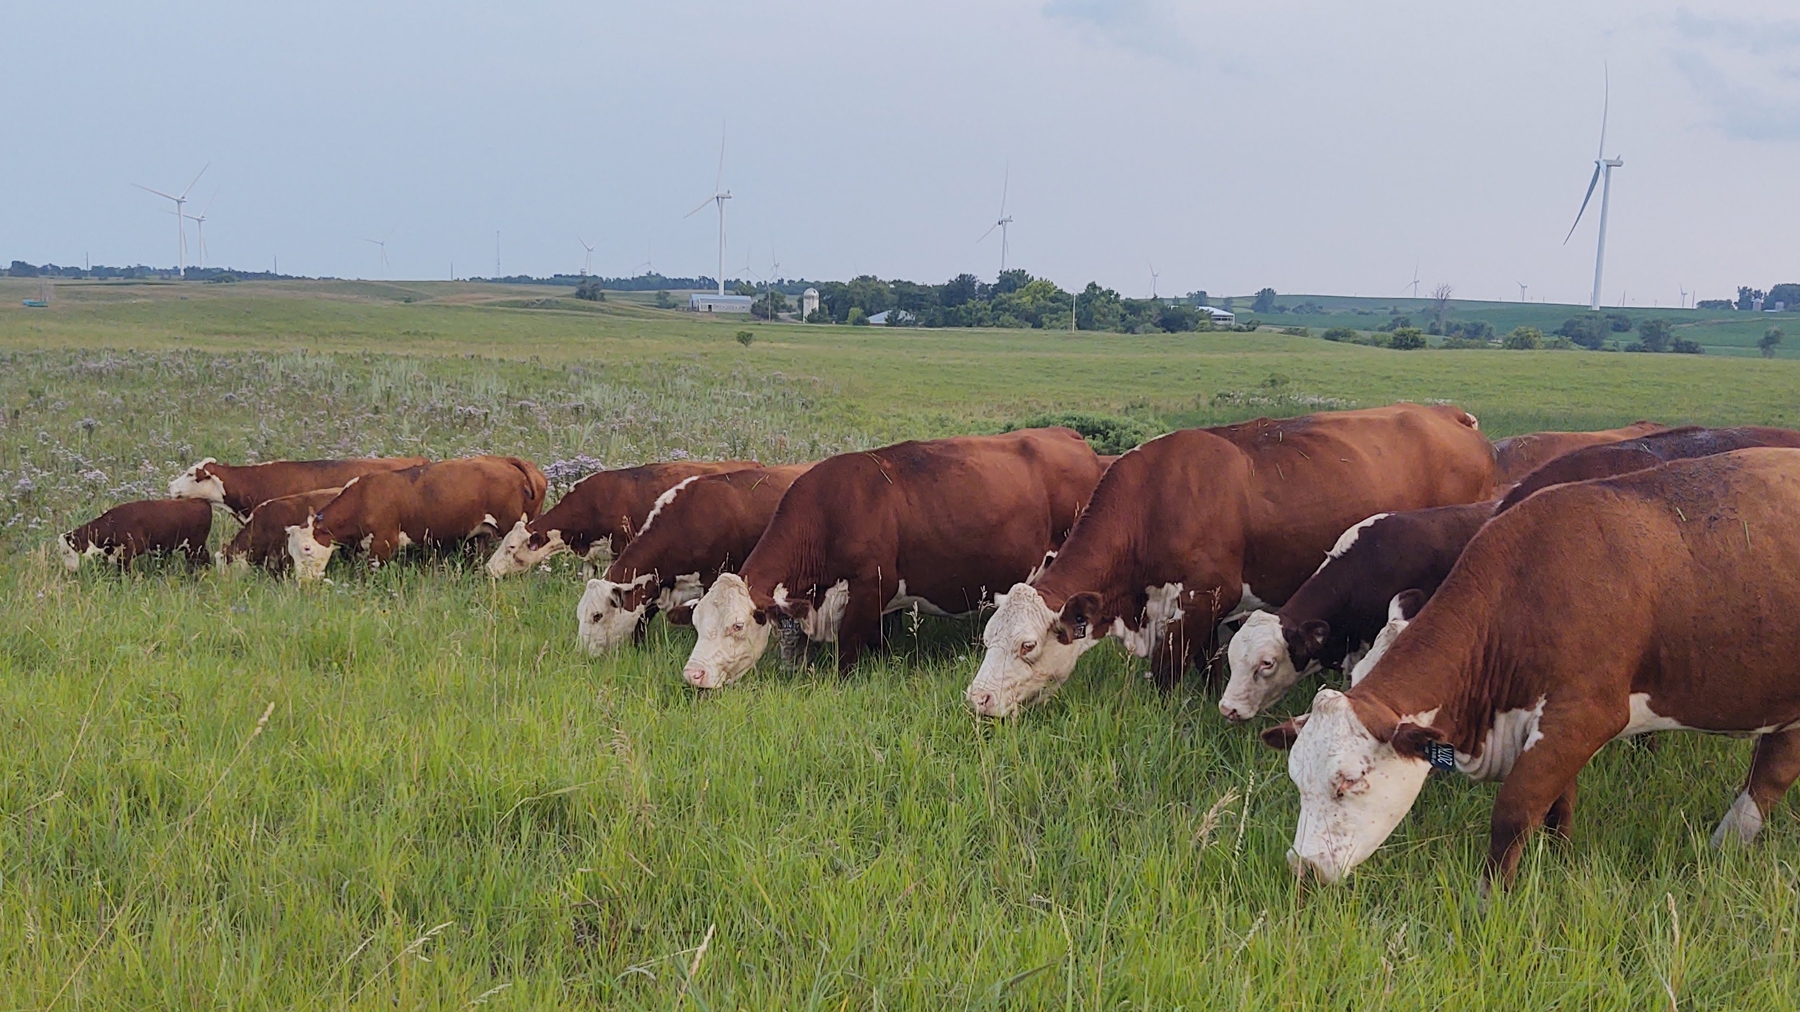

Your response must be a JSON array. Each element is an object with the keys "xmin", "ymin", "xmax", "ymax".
[{"xmin": 1481, "ymin": 709, "xmax": 1629, "ymax": 891}]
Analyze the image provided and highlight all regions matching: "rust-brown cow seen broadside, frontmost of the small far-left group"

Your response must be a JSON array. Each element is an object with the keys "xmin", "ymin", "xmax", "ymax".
[{"xmin": 288, "ymin": 457, "xmax": 547, "ymax": 580}]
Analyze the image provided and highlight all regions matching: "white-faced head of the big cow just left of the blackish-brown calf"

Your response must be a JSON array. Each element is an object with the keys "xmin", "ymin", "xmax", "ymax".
[{"xmin": 963, "ymin": 583, "xmax": 1102, "ymax": 717}]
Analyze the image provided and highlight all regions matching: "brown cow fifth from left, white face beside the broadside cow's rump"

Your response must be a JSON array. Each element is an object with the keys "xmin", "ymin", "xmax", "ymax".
[{"xmin": 488, "ymin": 461, "xmax": 758, "ymax": 576}]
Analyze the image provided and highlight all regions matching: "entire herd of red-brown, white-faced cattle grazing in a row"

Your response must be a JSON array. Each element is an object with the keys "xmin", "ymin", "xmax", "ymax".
[{"xmin": 58, "ymin": 403, "xmax": 1800, "ymax": 882}]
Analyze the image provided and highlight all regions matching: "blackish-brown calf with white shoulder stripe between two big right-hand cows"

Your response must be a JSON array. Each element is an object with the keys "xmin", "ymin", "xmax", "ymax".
[{"xmin": 1219, "ymin": 502, "xmax": 1494, "ymax": 720}]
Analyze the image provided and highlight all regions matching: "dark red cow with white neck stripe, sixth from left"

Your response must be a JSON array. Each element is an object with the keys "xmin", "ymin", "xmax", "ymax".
[{"xmin": 576, "ymin": 465, "xmax": 812, "ymax": 654}]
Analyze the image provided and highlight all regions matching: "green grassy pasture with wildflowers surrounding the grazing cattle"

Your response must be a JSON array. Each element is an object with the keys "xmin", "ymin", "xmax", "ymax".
[{"xmin": 0, "ymin": 281, "xmax": 1800, "ymax": 1010}]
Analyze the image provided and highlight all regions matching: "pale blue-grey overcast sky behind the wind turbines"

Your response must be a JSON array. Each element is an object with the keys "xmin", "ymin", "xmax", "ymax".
[{"xmin": 0, "ymin": 0, "xmax": 1800, "ymax": 306}]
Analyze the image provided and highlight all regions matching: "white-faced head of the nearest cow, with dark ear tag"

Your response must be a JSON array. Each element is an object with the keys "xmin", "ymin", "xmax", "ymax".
[{"xmin": 1262, "ymin": 688, "xmax": 1442, "ymax": 882}]
